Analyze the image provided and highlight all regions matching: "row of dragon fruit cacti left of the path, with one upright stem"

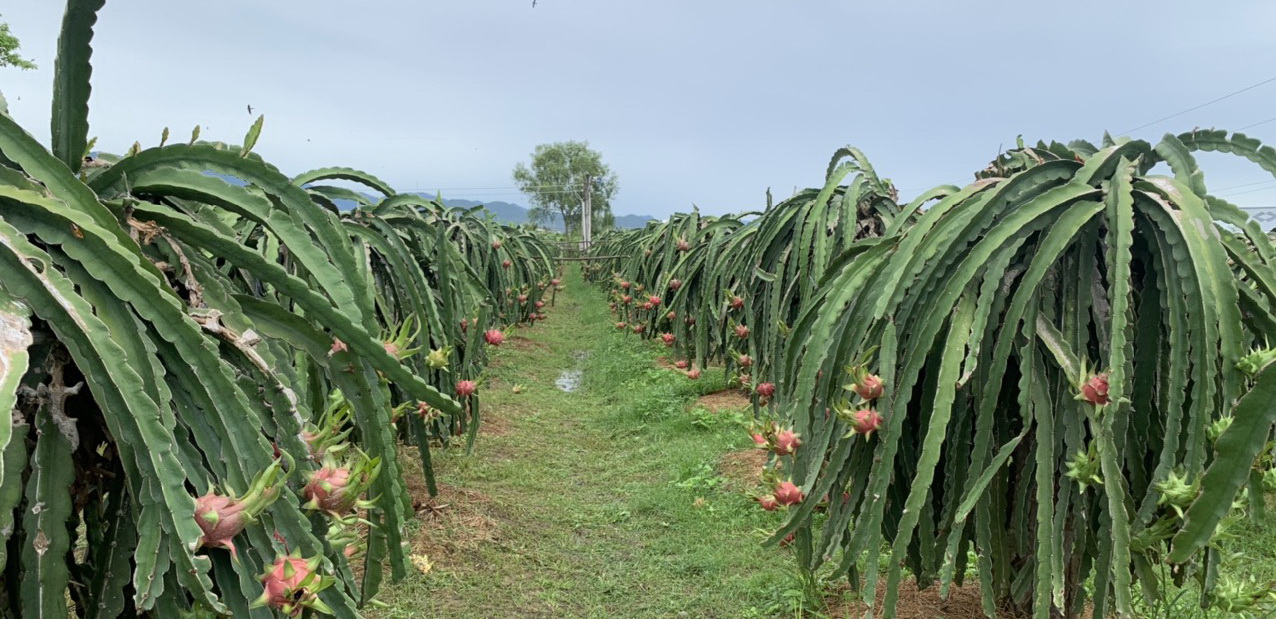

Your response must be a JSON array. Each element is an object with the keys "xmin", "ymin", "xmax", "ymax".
[{"xmin": 0, "ymin": 0, "xmax": 553, "ymax": 619}]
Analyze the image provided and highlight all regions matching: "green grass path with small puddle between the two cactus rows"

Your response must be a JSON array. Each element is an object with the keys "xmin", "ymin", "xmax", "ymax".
[{"xmin": 375, "ymin": 272, "xmax": 791, "ymax": 619}]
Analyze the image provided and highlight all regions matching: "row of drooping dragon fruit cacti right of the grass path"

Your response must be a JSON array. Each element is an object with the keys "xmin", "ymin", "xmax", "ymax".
[{"xmin": 588, "ymin": 136, "xmax": 1276, "ymax": 619}]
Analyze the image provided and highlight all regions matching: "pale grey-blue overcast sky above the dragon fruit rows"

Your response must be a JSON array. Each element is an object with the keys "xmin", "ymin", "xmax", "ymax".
[{"xmin": 0, "ymin": 0, "xmax": 1276, "ymax": 217}]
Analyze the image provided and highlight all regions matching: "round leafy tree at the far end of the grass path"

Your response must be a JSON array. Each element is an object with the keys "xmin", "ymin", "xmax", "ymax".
[{"xmin": 514, "ymin": 140, "xmax": 619, "ymax": 232}]
